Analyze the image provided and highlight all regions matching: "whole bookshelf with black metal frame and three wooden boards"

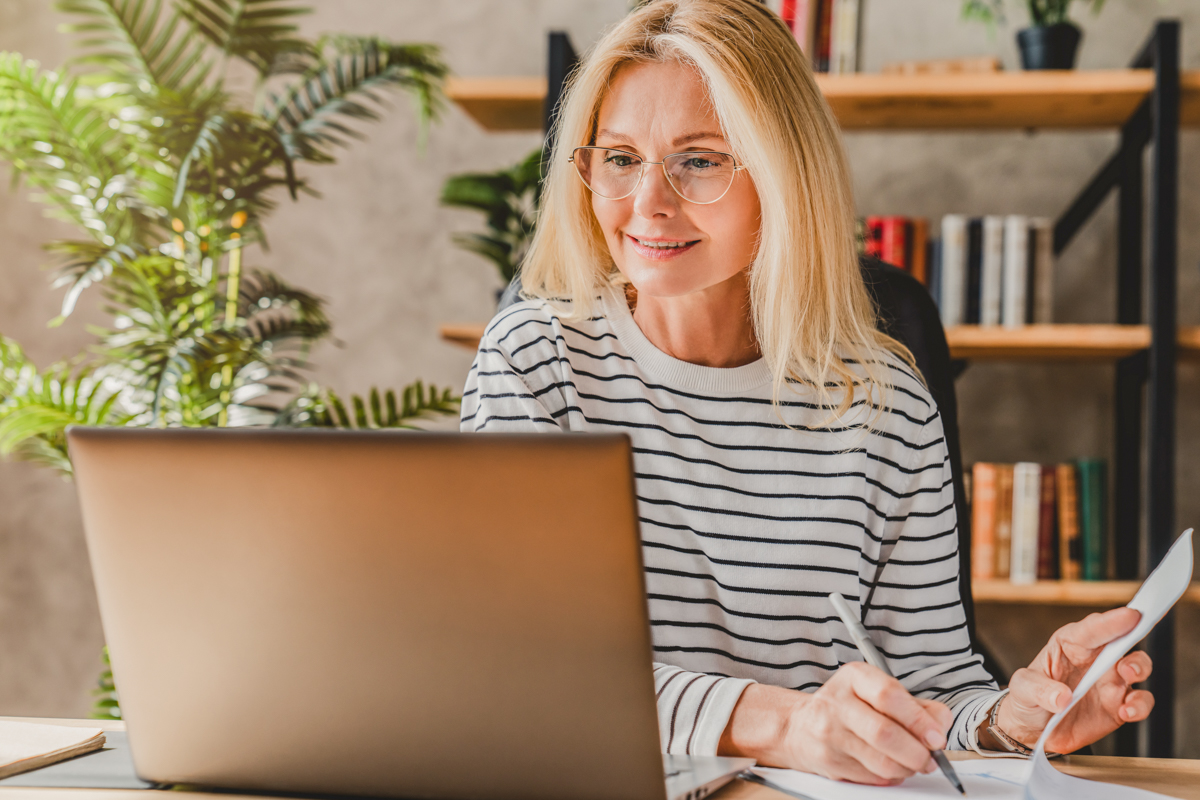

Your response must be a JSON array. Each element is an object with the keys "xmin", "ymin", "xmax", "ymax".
[{"xmin": 440, "ymin": 20, "xmax": 1200, "ymax": 757}]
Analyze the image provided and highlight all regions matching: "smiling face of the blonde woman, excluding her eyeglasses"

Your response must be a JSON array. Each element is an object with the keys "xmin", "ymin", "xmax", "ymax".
[{"xmin": 592, "ymin": 62, "xmax": 761, "ymax": 297}]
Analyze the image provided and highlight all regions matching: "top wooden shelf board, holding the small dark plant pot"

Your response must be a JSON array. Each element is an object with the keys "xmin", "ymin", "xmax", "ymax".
[{"xmin": 446, "ymin": 70, "xmax": 1200, "ymax": 131}]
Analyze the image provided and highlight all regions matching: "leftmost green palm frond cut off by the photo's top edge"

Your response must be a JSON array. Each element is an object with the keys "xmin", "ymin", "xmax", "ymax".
[{"xmin": 55, "ymin": 0, "xmax": 212, "ymax": 95}]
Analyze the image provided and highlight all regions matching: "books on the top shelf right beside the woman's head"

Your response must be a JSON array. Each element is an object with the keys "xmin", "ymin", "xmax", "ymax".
[{"xmin": 766, "ymin": 0, "xmax": 863, "ymax": 74}]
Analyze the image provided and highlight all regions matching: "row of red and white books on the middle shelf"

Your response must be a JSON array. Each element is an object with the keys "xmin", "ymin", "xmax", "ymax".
[{"xmin": 858, "ymin": 213, "xmax": 1054, "ymax": 327}]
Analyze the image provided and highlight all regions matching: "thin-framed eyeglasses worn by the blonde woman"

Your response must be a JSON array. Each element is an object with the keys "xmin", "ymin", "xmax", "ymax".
[{"xmin": 568, "ymin": 148, "xmax": 745, "ymax": 205}]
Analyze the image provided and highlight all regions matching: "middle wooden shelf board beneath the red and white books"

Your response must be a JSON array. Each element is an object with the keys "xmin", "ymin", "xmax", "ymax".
[{"xmin": 439, "ymin": 323, "xmax": 1200, "ymax": 361}]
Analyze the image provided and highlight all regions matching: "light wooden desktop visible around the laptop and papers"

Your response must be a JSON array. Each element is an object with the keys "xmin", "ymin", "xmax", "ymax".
[{"xmin": 0, "ymin": 717, "xmax": 1200, "ymax": 800}]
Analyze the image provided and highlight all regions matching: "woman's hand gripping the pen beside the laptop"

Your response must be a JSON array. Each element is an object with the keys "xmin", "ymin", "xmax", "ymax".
[{"xmin": 718, "ymin": 662, "xmax": 952, "ymax": 786}]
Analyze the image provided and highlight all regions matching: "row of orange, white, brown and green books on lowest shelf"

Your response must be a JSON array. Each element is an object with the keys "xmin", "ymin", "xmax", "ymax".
[{"xmin": 967, "ymin": 458, "xmax": 1108, "ymax": 584}]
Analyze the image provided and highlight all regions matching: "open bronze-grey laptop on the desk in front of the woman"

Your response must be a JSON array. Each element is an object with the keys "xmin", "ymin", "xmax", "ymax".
[{"xmin": 67, "ymin": 427, "xmax": 752, "ymax": 800}]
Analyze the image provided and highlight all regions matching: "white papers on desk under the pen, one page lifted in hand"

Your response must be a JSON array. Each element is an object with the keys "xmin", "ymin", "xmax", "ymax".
[{"xmin": 754, "ymin": 528, "xmax": 1192, "ymax": 800}]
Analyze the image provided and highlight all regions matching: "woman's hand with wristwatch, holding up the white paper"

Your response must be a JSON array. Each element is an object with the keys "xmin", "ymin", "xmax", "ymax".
[{"xmin": 980, "ymin": 608, "xmax": 1154, "ymax": 753}]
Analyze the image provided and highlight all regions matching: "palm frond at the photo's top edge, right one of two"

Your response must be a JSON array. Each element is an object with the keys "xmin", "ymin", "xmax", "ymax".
[{"xmin": 176, "ymin": 0, "xmax": 312, "ymax": 77}]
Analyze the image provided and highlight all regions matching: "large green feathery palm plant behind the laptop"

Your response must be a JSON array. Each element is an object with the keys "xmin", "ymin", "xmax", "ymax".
[{"xmin": 0, "ymin": 0, "xmax": 458, "ymax": 717}]
